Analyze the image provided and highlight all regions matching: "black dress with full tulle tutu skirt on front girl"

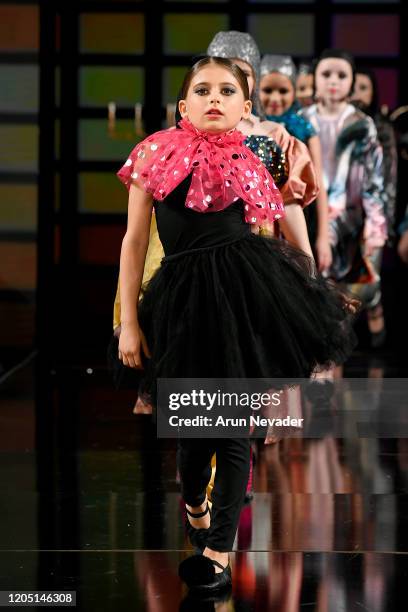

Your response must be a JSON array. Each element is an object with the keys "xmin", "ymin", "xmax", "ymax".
[{"xmin": 125, "ymin": 177, "xmax": 355, "ymax": 399}]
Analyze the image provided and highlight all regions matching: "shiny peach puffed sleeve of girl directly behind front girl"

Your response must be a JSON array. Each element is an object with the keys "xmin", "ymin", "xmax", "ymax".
[{"xmin": 270, "ymin": 123, "xmax": 319, "ymax": 208}]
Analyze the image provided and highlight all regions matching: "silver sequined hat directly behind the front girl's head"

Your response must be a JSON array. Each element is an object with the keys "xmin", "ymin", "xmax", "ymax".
[{"xmin": 207, "ymin": 30, "xmax": 261, "ymax": 81}]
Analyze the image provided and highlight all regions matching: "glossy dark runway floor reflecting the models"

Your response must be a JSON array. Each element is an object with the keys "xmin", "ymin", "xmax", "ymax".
[{"xmin": 0, "ymin": 354, "xmax": 408, "ymax": 612}]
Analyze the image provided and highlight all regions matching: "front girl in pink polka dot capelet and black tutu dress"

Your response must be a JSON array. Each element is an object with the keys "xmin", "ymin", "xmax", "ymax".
[{"xmin": 118, "ymin": 58, "xmax": 352, "ymax": 593}]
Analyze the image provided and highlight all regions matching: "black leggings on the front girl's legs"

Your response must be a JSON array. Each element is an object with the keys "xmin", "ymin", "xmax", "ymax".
[{"xmin": 177, "ymin": 438, "xmax": 250, "ymax": 552}]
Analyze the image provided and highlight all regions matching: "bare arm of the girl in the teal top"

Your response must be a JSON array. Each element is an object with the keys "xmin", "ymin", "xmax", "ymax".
[{"xmin": 308, "ymin": 136, "xmax": 332, "ymax": 272}]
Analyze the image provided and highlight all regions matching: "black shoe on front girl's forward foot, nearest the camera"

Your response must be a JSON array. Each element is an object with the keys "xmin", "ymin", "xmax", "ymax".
[{"xmin": 179, "ymin": 555, "xmax": 232, "ymax": 596}]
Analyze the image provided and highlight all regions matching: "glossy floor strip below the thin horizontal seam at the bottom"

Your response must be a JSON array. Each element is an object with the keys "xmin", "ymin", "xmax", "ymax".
[{"xmin": 0, "ymin": 550, "xmax": 408, "ymax": 612}]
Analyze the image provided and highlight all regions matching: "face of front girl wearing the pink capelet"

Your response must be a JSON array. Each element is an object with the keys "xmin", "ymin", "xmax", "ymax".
[{"xmin": 179, "ymin": 65, "xmax": 252, "ymax": 133}]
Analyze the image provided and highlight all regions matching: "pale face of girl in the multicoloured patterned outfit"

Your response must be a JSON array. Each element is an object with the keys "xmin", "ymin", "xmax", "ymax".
[{"xmin": 315, "ymin": 57, "xmax": 353, "ymax": 102}]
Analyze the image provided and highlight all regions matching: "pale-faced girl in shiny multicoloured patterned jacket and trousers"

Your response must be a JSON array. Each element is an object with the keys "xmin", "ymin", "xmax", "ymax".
[{"xmin": 304, "ymin": 49, "xmax": 387, "ymax": 307}]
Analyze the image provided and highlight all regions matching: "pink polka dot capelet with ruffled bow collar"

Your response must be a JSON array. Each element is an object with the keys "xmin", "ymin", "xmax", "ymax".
[{"xmin": 117, "ymin": 119, "xmax": 285, "ymax": 225}]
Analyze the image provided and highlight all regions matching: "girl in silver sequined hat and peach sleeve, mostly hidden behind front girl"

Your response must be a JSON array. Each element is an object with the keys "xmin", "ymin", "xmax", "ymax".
[{"xmin": 113, "ymin": 31, "xmax": 318, "ymax": 392}]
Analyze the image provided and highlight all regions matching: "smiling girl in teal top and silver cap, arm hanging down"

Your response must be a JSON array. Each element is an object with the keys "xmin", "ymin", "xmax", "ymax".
[{"xmin": 259, "ymin": 55, "xmax": 332, "ymax": 272}]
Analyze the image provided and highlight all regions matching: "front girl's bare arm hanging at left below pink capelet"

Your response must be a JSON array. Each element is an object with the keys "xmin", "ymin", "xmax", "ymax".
[{"xmin": 119, "ymin": 184, "xmax": 153, "ymax": 368}]
